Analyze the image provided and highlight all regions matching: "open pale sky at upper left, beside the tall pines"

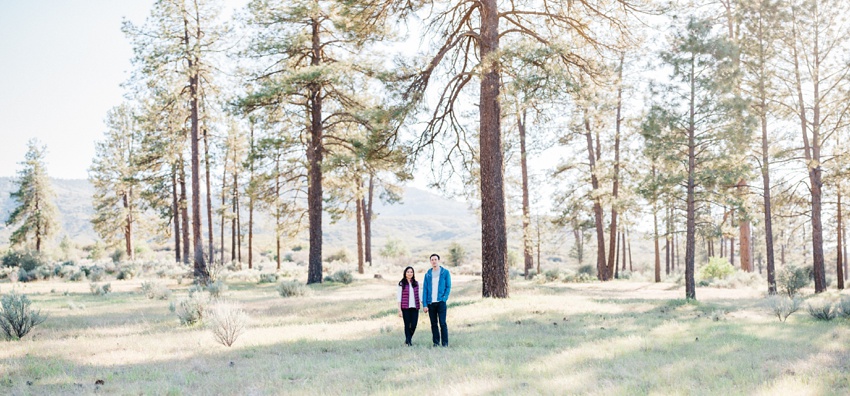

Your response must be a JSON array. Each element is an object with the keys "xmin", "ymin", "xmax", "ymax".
[{"xmin": 0, "ymin": 0, "xmax": 153, "ymax": 179}]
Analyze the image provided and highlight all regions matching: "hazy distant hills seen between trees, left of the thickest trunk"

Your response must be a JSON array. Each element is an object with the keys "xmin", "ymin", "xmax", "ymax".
[{"xmin": 0, "ymin": 177, "xmax": 480, "ymax": 254}]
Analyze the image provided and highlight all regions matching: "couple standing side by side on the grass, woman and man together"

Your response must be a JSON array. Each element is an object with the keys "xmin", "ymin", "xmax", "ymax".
[{"xmin": 398, "ymin": 254, "xmax": 452, "ymax": 347}]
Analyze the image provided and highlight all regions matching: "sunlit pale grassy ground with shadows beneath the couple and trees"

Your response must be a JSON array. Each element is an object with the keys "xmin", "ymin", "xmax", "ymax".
[{"xmin": 0, "ymin": 271, "xmax": 850, "ymax": 395}]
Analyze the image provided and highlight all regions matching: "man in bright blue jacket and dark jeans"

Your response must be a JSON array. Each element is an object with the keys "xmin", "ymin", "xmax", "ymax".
[{"xmin": 422, "ymin": 254, "xmax": 452, "ymax": 347}]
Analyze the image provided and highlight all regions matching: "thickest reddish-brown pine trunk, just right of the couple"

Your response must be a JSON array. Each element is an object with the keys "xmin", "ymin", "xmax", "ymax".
[{"xmin": 478, "ymin": 0, "xmax": 509, "ymax": 298}]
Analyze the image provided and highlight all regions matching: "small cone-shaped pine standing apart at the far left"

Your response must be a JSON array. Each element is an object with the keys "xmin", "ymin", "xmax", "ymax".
[{"xmin": 6, "ymin": 139, "xmax": 58, "ymax": 252}]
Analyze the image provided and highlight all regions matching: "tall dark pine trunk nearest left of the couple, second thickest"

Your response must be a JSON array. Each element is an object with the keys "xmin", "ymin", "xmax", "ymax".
[{"xmin": 307, "ymin": 19, "xmax": 324, "ymax": 284}]
